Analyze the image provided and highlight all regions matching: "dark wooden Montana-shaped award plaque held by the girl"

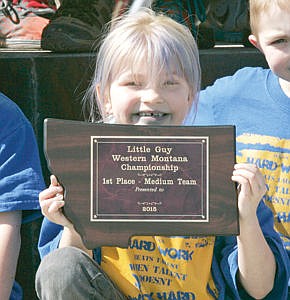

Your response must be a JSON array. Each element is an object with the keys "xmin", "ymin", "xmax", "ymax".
[{"xmin": 44, "ymin": 119, "xmax": 239, "ymax": 249}]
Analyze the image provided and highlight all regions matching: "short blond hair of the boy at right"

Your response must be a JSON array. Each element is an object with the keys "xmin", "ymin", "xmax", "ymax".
[{"xmin": 249, "ymin": 0, "xmax": 289, "ymax": 35}]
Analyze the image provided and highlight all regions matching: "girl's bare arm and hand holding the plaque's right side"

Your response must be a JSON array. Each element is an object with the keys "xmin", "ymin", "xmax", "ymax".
[{"xmin": 233, "ymin": 164, "xmax": 276, "ymax": 299}]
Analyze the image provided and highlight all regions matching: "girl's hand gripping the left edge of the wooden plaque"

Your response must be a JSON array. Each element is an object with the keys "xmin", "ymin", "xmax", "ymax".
[{"xmin": 39, "ymin": 175, "xmax": 73, "ymax": 228}]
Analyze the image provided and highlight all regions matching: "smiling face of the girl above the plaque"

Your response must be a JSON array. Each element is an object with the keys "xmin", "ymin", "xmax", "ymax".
[{"xmin": 105, "ymin": 64, "xmax": 193, "ymax": 125}]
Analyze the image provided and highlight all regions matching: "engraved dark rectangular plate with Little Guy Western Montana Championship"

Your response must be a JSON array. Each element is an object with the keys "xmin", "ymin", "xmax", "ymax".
[{"xmin": 91, "ymin": 136, "xmax": 209, "ymax": 222}]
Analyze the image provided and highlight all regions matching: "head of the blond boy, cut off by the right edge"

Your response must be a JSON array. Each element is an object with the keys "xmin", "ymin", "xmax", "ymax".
[{"xmin": 249, "ymin": 0, "xmax": 290, "ymax": 83}]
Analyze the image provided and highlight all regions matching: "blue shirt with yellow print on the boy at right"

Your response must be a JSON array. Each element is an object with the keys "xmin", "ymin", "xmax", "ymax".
[{"xmin": 185, "ymin": 67, "xmax": 290, "ymax": 294}]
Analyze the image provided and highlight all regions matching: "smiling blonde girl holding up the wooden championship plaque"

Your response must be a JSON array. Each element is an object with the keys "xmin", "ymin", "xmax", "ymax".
[{"xmin": 36, "ymin": 9, "xmax": 288, "ymax": 300}]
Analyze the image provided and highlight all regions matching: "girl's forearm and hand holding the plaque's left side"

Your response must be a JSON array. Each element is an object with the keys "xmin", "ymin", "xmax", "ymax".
[{"xmin": 39, "ymin": 175, "xmax": 92, "ymax": 257}]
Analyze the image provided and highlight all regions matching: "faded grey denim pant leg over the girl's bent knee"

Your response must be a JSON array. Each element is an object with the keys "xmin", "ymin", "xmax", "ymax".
[{"xmin": 35, "ymin": 247, "xmax": 127, "ymax": 300}]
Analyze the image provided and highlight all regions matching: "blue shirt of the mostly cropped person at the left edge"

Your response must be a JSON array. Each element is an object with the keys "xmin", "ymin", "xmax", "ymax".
[{"xmin": 0, "ymin": 93, "xmax": 45, "ymax": 299}]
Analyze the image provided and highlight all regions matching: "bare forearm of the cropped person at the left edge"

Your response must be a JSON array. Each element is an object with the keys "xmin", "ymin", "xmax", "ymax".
[{"xmin": 0, "ymin": 211, "xmax": 22, "ymax": 300}]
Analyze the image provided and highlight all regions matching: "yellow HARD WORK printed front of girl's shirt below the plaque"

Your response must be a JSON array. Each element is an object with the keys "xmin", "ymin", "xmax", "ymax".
[{"xmin": 101, "ymin": 236, "xmax": 218, "ymax": 300}]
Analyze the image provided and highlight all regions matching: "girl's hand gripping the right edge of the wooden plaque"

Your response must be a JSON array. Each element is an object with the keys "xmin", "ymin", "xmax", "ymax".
[{"xmin": 232, "ymin": 163, "xmax": 267, "ymax": 220}]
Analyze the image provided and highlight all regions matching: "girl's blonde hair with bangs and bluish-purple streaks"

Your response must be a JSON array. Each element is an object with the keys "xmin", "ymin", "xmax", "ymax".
[{"xmin": 84, "ymin": 8, "xmax": 201, "ymax": 121}]
